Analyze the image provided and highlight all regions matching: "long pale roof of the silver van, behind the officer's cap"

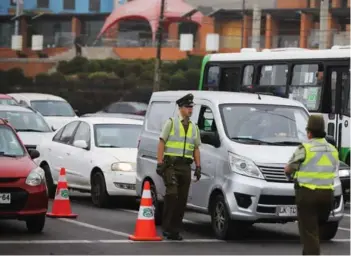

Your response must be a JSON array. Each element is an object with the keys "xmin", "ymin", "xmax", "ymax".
[{"xmin": 151, "ymin": 91, "xmax": 304, "ymax": 108}]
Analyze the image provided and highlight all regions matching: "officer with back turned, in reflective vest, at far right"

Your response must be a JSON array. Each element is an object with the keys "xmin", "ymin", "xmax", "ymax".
[{"xmin": 285, "ymin": 115, "xmax": 339, "ymax": 255}]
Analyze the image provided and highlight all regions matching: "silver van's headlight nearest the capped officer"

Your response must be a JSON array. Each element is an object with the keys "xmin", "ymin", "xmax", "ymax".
[{"xmin": 229, "ymin": 152, "xmax": 264, "ymax": 179}]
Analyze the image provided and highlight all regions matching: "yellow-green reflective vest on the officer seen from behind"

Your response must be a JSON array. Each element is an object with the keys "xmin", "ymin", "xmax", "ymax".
[{"xmin": 295, "ymin": 139, "xmax": 339, "ymax": 190}]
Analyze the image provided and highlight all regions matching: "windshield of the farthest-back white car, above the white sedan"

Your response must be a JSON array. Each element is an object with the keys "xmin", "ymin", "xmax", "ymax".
[{"xmin": 30, "ymin": 100, "xmax": 76, "ymax": 117}]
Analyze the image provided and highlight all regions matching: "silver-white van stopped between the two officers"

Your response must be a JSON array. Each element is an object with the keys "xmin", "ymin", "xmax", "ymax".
[{"xmin": 136, "ymin": 91, "xmax": 344, "ymax": 240}]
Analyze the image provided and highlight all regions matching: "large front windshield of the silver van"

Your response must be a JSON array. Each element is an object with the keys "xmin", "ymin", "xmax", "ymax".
[{"xmin": 220, "ymin": 104, "xmax": 308, "ymax": 146}]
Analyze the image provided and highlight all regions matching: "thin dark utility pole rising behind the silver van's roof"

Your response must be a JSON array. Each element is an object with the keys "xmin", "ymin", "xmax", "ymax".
[{"xmin": 153, "ymin": 0, "xmax": 165, "ymax": 92}]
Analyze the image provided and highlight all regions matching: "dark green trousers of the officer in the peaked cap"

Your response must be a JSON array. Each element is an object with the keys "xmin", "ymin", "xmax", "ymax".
[{"xmin": 162, "ymin": 164, "xmax": 191, "ymax": 233}]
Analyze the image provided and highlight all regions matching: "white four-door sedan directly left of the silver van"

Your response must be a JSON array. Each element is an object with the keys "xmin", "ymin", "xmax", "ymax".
[{"xmin": 36, "ymin": 117, "xmax": 143, "ymax": 207}]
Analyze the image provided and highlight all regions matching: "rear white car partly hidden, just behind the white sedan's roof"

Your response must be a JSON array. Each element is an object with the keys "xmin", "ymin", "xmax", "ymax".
[{"xmin": 8, "ymin": 93, "xmax": 78, "ymax": 130}]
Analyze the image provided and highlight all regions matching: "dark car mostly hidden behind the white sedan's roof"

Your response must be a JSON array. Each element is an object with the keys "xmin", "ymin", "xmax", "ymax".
[{"xmin": 99, "ymin": 101, "xmax": 147, "ymax": 116}]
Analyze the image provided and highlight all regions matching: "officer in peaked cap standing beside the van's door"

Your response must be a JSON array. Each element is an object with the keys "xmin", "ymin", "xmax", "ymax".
[{"xmin": 156, "ymin": 94, "xmax": 201, "ymax": 240}]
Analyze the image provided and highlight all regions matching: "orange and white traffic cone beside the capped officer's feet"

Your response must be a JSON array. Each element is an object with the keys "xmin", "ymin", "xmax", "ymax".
[{"xmin": 129, "ymin": 181, "xmax": 162, "ymax": 241}]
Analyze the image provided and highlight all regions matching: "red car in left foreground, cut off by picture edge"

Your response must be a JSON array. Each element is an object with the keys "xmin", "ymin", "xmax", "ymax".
[{"xmin": 0, "ymin": 118, "xmax": 49, "ymax": 233}]
